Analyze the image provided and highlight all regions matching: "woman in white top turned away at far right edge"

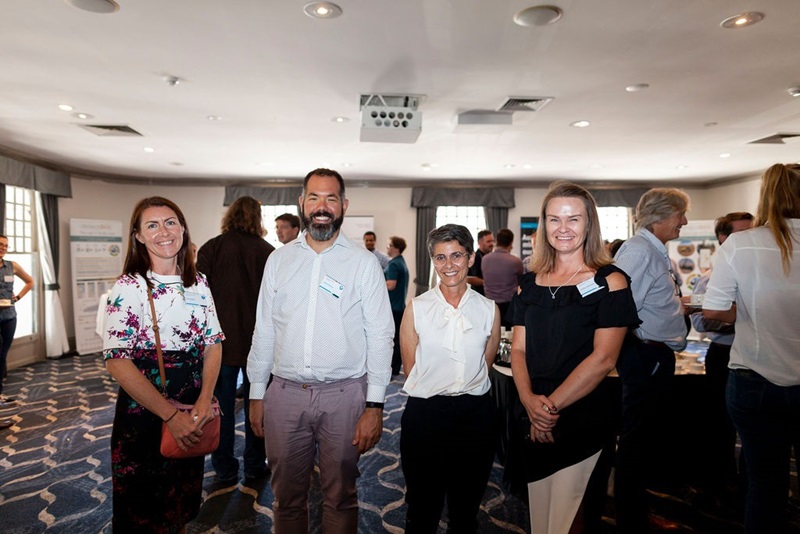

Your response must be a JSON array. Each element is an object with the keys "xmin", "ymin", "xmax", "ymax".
[{"xmin": 703, "ymin": 164, "xmax": 800, "ymax": 533}]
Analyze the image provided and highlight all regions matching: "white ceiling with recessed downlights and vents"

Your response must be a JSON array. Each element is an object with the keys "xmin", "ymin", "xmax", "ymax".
[{"xmin": 0, "ymin": 0, "xmax": 800, "ymax": 185}]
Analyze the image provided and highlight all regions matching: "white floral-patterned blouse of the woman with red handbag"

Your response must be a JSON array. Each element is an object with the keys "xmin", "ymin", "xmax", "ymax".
[{"xmin": 103, "ymin": 271, "xmax": 225, "ymax": 360}]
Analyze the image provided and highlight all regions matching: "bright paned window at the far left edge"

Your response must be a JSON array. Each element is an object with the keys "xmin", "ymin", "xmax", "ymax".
[{"xmin": 5, "ymin": 185, "xmax": 36, "ymax": 338}]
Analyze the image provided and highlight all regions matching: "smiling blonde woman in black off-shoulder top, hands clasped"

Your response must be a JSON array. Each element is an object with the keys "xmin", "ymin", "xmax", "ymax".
[{"xmin": 509, "ymin": 182, "xmax": 640, "ymax": 534}]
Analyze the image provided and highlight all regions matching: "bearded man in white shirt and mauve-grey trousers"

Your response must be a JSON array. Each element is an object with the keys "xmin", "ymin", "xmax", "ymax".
[{"xmin": 247, "ymin": 169, "xmax": 394, "ymax": 534}]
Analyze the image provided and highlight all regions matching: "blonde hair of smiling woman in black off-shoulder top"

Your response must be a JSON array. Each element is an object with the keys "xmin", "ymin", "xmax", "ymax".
[{"xmin": 531, "ymin": 181, "xmax": 613, "ymax": 273}]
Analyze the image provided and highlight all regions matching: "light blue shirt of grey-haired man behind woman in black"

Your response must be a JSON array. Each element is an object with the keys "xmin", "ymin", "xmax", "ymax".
[{"xmin": 614, "ymin": 228, "xmax": 687, "ymax": 350}]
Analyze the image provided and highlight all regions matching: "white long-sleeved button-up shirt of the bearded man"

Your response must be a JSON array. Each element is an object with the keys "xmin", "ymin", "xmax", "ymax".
[{"xmin": 247, "ymin": 232, "xmax": 394, "ymax": 402}]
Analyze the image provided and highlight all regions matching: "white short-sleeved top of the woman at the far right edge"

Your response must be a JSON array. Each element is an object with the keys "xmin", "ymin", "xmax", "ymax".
[{"xmin": 703, "ymin": 219, "xmax": 800, "ymax": 386}]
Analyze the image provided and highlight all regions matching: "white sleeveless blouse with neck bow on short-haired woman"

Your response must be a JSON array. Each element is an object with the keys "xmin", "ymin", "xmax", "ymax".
[{"xmin": 403, "ymin": 285, "xmax": 495, "ymax": 399}]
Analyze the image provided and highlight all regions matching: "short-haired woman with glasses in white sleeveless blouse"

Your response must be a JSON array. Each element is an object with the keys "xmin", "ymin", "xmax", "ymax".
[{"xmin": 400, "ymin": 224, "xmax": 500, "ymax": 534}]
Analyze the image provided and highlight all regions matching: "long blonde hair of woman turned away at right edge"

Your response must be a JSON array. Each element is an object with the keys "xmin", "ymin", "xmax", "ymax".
[{"xmin": 753, "ymin": 163, "xmax": 800, "ymax": 276}]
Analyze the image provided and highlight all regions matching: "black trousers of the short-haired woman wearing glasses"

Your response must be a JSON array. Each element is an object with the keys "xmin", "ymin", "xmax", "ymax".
[{"xmin": 400, "ymin": 393, "xmax": 499, "ymax": 534}]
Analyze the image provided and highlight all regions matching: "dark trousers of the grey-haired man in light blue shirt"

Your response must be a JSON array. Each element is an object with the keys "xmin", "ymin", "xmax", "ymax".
[{"xmin": 614, "ymin": 334, "xmax": 675, "ymax": 534}]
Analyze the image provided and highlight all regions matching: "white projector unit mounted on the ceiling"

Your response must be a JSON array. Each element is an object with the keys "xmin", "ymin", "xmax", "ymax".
[{"xmin": 361, "ymin": 95, "xmax": 422, "ymax": 143}]
